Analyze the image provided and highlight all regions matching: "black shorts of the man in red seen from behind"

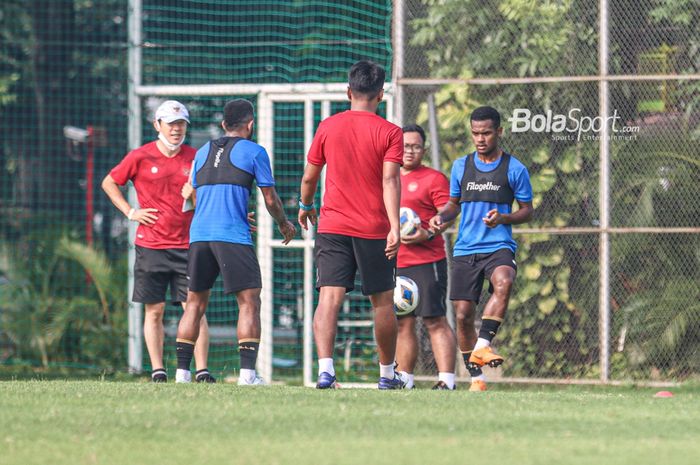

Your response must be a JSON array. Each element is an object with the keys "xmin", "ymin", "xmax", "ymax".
[{"xmin": 314, "ymin": 233, "xmax": 396, "ymax": 295}]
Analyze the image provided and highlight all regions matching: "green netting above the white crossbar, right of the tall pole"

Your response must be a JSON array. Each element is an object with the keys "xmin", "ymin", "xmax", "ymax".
[{"xmin": 143, "ymin": 0, "xmax": 392, "ymax": 84}]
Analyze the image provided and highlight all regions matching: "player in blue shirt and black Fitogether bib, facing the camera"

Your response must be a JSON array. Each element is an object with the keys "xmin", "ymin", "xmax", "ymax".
[{"xmin": 430, "ymin": 107, "xmax": 533, "ymax": 391}]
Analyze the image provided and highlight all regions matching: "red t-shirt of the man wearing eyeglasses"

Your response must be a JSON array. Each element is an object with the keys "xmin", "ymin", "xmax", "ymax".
[{"xmin": 396, "ymin": 166, "xmax": 450, "ymax": 268}]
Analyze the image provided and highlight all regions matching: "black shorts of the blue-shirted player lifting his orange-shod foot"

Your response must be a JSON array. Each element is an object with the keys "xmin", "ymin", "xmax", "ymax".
[{"xmin": 450, "ymin": 249, "xmax": 518, "ymax": 303}]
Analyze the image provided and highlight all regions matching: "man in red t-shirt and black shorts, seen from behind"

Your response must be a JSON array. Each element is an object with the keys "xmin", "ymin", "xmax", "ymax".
[{"xmin": 298, "ymin": 61, "xmax": 406, "ymax": 389}]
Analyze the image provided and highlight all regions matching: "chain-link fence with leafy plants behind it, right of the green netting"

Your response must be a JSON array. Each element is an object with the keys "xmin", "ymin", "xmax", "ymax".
[{"xmin": 398, "ymin": 0, "xmax": 700, "ymax": 380}]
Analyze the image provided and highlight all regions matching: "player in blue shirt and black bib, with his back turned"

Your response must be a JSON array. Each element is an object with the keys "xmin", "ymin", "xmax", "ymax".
[{"xmin": 175, "ymin": 99, "xmax": 296, "ymax": 385}]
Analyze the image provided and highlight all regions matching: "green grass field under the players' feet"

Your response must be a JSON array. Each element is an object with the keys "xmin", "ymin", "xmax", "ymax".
[{"xmin": 0, "ymin": 381, "xmax": 700, "ymax": 465}]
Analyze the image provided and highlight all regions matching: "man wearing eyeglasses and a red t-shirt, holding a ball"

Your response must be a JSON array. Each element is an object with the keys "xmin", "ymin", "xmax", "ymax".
[{"xmin": 396, "ymin": 124, "xmax": 457, "ymax": 390}]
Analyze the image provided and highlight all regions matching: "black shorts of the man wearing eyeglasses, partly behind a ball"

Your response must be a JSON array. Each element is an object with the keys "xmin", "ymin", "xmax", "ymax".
[{"xmin": 396, "ymin": 258, "xmax": 447, "ymax": 318}]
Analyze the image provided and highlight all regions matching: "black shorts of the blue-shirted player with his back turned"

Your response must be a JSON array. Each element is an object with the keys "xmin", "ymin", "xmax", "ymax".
[{"xmin": 187, "ymin": 242, "xmax": 262, "ymax": 294}]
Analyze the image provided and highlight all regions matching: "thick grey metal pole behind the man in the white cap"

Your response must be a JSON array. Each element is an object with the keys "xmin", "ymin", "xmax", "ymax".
[{"xmin": 128, "ymin": 0, "xmax": 143, "ymax": 373}]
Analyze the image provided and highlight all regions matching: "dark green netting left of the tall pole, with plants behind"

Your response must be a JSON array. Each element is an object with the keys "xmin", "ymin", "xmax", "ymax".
[{"xmin": 0, "ymin": 0, "xmax": 127, "ymax": 370}]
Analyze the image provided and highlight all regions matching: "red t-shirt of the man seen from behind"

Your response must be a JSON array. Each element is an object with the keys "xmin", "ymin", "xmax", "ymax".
[{"xmin": 307, "ymin": 110, "xmax": 403, "ymax": 239}]
